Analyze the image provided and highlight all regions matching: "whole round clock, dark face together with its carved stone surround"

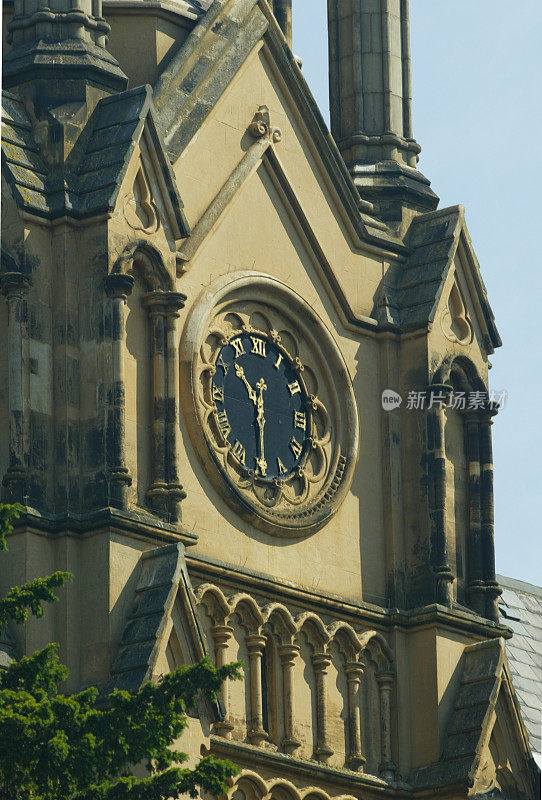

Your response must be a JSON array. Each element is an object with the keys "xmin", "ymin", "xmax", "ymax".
[{"xmin": 180, "ymin": 272, "xmax": 358, "ymax": 536}]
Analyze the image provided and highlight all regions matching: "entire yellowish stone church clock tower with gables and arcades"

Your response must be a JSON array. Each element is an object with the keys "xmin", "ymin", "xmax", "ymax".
[{"xmin": 0, "ymin": 0, "xmax": 537, "ymax": 800}]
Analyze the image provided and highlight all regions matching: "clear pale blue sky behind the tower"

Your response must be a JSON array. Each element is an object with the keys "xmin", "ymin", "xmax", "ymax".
[{"xmin": 293, "ymin": 0, "xmax": 542, "ymax": 585}]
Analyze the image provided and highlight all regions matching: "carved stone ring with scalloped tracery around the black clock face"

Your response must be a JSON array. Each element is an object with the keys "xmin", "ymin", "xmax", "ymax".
[{"xmin": 180, "ymin": 271, "xmax": 359, "ymax": 537}]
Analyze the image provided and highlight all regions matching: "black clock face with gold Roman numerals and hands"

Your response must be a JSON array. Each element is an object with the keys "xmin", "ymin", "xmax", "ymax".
[{"xmin": 211, "ymin": 333, "xmax": 311, "ymax": 481}]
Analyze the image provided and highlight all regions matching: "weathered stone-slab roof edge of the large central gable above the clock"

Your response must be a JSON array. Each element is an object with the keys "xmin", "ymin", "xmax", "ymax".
[{"xmin": 154, "ymin": 0, "xmax": 404, "ymax": 250}]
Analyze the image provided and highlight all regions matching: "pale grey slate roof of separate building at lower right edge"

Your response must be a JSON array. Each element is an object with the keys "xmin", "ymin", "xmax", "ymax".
[{"xmin": 497, "ymin": 575, "xmax": 542, "ymax": 765}]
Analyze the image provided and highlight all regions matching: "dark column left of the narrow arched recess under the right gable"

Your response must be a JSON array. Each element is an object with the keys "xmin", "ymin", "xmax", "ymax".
[{"xmin": 427, "ymin": 384, "xmax": 454, "ymax": 606}]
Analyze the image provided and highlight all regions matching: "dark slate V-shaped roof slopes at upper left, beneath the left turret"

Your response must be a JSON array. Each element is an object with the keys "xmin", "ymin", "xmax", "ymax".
[{"xmin": 2, "ymin": 86, "xmax": 188, "ymax": 237}]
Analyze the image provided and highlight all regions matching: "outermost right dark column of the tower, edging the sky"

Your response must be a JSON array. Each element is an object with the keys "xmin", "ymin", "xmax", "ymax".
[{"xmin": 480, "ymin": 410, "xmax": 502, "ymax": 622}]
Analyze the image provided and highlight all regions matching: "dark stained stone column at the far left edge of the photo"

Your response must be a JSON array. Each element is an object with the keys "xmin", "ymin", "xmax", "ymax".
[{"xmin": 0, "ymin": 272, "xmax": 30, "ymax": 505}]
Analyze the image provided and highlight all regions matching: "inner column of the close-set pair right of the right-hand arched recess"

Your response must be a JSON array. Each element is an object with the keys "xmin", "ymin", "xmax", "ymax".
[{"xmin": 465, "ymin": 413, "xmax": 486, "ymax": 616}]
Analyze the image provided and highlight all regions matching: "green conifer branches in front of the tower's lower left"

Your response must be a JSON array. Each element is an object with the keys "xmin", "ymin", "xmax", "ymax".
[{"xmin": 0, "ymin": 506, "xmax": 240, "ymax": 800}]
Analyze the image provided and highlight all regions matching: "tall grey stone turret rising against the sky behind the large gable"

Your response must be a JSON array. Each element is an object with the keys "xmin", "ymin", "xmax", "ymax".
[{"xmin": 328, "ymin": 0, "xmax": 438, "ymax": 225}]
